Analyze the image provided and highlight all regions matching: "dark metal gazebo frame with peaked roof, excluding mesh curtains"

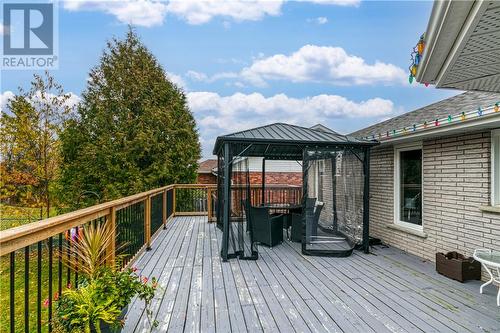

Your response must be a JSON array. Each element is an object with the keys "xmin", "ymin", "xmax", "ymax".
[{"xmin": 213, "ymin": 123, "xmax": 378, "ymax": 261}]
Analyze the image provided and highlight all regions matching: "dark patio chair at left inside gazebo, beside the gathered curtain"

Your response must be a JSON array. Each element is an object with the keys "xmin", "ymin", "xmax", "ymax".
[{"xmin": 249, "ymin": 206, "xmax": 283, "ymax": 247}]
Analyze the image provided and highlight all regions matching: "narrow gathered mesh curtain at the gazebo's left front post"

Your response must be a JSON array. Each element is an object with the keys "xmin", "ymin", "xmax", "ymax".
[{"xmin": 217, "ymin": 145, "xmax": 258, "ymax": 260}]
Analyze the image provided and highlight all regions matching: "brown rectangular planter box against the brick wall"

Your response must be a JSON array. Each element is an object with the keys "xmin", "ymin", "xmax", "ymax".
[{"xmin": 436, "ymin": 251, "xmax": 481, "ymax": 282}]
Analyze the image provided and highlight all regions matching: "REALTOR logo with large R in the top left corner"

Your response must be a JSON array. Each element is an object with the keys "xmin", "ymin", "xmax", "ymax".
[{"xmin": 2, "ymin": 3, "xmax": 57, "ymax": 69}]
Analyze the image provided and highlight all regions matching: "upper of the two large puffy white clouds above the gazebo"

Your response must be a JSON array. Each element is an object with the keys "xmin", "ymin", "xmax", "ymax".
[{"xmin": 189, "ymin": 45, "xmax": 407, "ymax": 86}]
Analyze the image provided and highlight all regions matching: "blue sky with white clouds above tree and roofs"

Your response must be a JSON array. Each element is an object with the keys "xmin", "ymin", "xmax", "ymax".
[{"xmin": 0, "ymin": 0, "xmax": 459, "ymax": 158}]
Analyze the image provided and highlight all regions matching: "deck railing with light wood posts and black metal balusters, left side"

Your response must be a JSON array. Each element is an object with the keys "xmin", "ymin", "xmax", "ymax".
[{"xmin": 0, "ymin": 184, "xmax": 215, "ymax": 333}]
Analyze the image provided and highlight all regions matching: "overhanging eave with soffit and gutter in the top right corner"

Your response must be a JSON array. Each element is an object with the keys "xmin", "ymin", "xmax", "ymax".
[{"xmin": 416, "ymin": 1, "xmax": 500, "ymax": 92}]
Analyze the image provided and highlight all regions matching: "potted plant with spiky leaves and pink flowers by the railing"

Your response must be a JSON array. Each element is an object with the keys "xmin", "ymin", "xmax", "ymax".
[{"xmin": 53, "ymin": 223, "xmax": 157, "ymax": 333}]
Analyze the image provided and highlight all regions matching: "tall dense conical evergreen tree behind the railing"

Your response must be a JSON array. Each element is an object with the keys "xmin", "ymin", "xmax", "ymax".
[{"xmin": 61, "ymin": 29, "xmax": 200, "ymax": 204}]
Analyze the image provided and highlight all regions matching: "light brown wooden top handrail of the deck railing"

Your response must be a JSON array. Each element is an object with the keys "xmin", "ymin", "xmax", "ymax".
[{"xmin": 0, "ymin": 184, "xmax": 216, "ymax": 256}]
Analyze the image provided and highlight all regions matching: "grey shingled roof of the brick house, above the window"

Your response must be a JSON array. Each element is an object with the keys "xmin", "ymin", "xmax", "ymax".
[{"xmin": 349, "ymin": 91, "xmax": 500, "ymax": 139}]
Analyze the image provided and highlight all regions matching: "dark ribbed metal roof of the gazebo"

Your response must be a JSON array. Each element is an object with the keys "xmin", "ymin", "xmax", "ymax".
[{"xmin": 213, "ymin": 123, "xmax": 377, "ymax": 157}]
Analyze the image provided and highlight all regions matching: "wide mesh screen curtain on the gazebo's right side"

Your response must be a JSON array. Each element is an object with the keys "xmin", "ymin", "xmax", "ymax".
[{"xmin": 302, "ymin": 147, "xmax": 365, "ymax": 257}]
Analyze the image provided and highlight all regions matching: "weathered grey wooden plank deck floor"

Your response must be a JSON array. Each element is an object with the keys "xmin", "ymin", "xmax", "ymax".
[{"xmin": 123, "ymin": 216, "xmax": 500, "ymax": 333}]
